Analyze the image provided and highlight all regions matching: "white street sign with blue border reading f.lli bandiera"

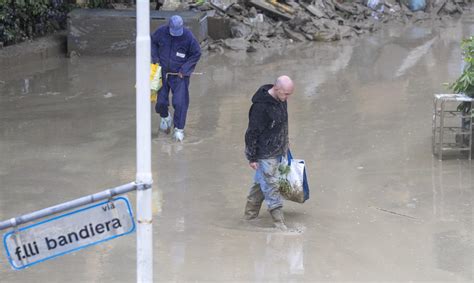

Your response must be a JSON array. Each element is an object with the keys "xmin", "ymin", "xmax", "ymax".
[{"xmin": 3, "ymin": 197, "xmax": 135, "ymax": 270}]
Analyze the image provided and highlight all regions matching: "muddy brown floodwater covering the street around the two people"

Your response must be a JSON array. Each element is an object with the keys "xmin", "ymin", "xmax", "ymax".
[{"xmin": 0, "ymin": 15, "xmax": 474, "ymax": 282}]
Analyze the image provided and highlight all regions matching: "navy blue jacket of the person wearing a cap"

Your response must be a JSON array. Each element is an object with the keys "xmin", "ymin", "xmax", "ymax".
[{"xmin": 151, "ymin": 25, "xmax": 201, "ymax": 76}]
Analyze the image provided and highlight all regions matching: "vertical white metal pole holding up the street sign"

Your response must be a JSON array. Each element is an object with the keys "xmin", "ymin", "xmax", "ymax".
[{"xmin": 136, "ymin": 0, "xmax": 153, "ymax": 283}]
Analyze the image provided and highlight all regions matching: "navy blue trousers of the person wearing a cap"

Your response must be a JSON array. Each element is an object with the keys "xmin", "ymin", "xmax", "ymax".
[{"xmin": 155, "ymin": 73, "xmax": 189, "ymax": 129}]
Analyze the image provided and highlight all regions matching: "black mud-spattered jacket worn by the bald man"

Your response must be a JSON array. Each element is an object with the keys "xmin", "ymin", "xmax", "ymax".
[{"xmin": 245, "ymin": 85, "xmax": 288, "ymax": 162}]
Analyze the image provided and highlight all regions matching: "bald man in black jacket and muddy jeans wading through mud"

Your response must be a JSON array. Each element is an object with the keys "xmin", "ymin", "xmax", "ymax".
[{"xmin": 245, "ymin": 76, "xmax": 294, "ymax": 230}]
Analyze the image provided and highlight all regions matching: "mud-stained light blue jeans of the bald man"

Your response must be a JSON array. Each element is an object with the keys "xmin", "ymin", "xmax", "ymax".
[{"xmin": 247, "ymin": 157, "xmax": 287, "ymax": 210}]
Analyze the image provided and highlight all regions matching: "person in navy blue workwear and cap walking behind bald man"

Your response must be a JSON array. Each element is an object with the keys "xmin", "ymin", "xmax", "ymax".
[{"xmin": 151, "ymin": 15, "xmax": 201, "ymax": 142}]
